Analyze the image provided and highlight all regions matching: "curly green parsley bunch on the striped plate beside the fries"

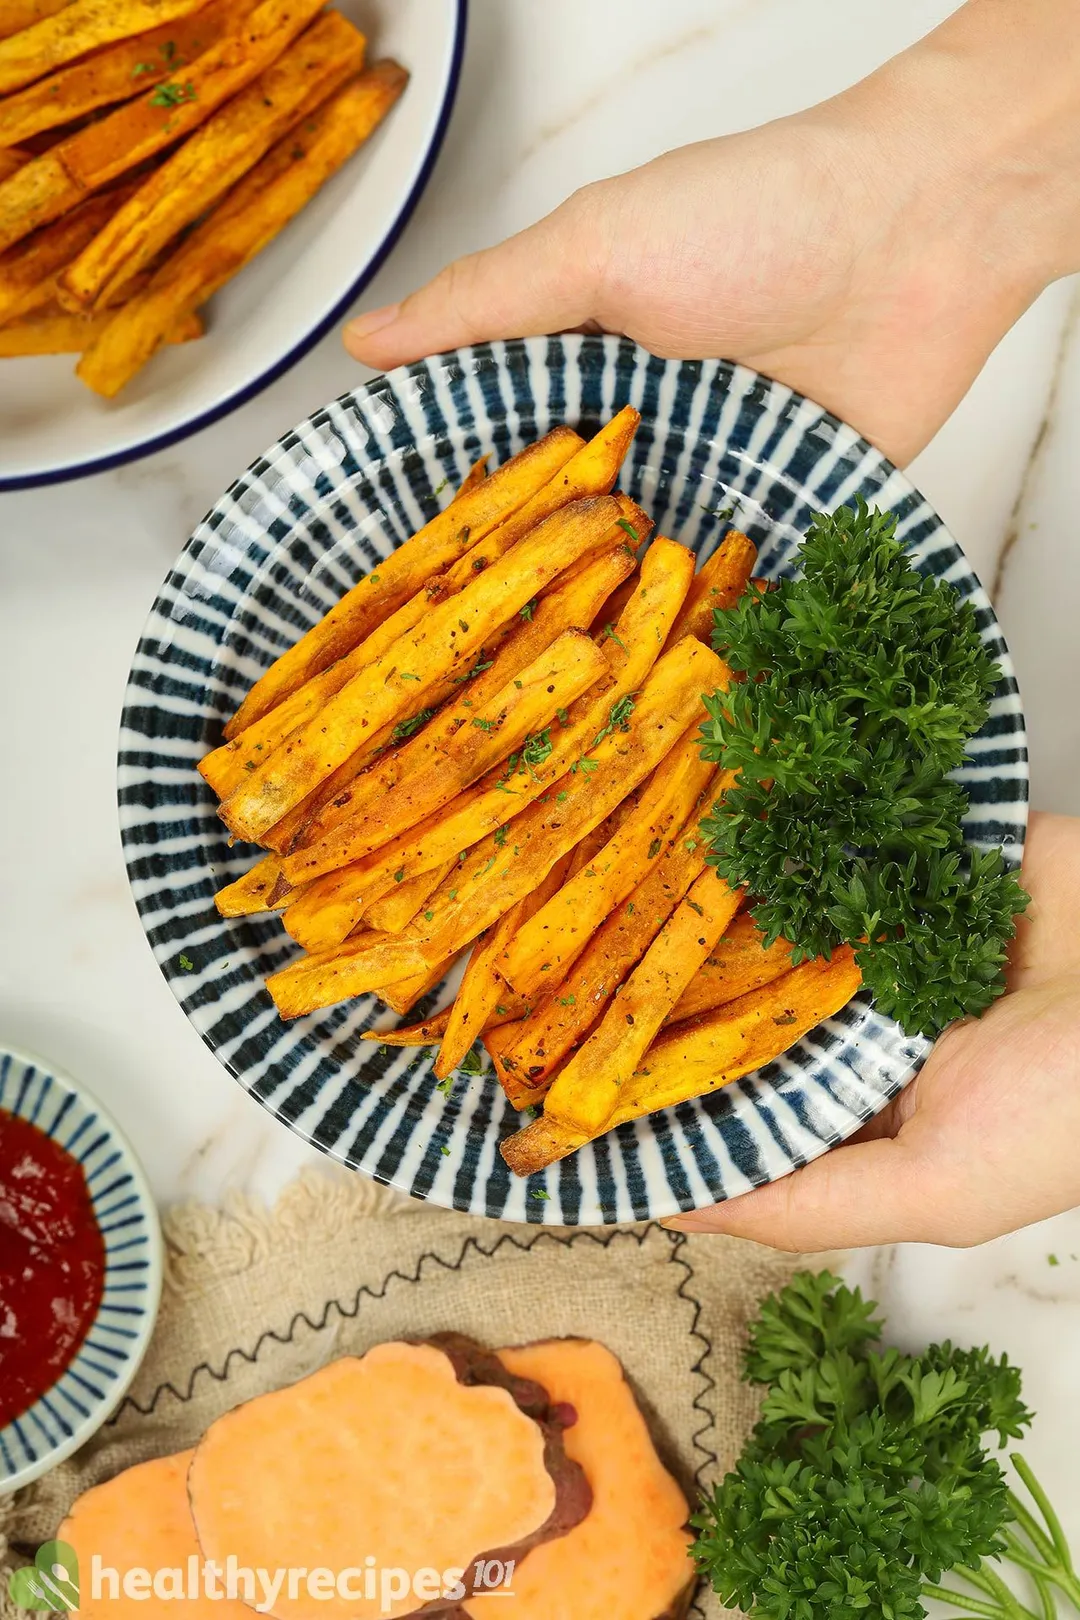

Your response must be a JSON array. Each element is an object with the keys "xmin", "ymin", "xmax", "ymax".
[{"xmin": 701, "ymin": 499, "xmax": 1027, "ymax": 1035}]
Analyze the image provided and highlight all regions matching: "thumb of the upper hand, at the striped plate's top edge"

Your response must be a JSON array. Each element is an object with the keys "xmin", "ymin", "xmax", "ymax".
[{"xmin": 345, "ymin": 196, "xmax": 597, "ymax": 371}]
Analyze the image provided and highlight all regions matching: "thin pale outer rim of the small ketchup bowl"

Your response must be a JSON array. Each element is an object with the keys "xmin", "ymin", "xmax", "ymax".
[{"xmin": 0, "ymin": 1040, "xmax": 165, "ymax": 1499}]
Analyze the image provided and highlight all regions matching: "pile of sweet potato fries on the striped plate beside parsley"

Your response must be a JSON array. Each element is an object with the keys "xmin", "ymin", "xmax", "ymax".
[{"xmin": 199, "ymin": 407, "xmax": 858, "ymax": 1175}]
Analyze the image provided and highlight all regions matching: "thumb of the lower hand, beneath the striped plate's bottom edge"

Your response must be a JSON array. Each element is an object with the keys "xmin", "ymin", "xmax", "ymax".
[{"xmin": 664, "ymin": 1139, "xmax": 936, "ymax": 1254}]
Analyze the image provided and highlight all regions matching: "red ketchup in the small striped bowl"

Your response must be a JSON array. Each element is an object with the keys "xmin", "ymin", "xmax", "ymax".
[{"xmin": 0, "ymin": 1110, "xmax": 105, "ymax": 1429}]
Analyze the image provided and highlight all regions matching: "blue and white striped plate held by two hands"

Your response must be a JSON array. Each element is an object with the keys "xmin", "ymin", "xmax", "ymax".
[{"xmin": 120, "ymin": 337, "xmax": 1028, "ymax": 1225}]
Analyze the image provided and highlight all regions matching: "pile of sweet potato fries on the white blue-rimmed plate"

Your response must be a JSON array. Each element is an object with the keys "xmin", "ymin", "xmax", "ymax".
[{"xmin": 0, "ymin": 0, "xmax": 408, "ymax": 399}]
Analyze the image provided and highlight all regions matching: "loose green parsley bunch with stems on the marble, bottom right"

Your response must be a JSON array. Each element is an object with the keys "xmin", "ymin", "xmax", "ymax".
[{"xmin": 691, "ymin": 1272, "xmax": 1080, "ymax": 1620}]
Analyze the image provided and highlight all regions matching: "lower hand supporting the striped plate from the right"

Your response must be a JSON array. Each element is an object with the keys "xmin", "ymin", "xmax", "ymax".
[{"xmin": 665, "ymin": 815, "xmax": 1080, "ymax": 1252}]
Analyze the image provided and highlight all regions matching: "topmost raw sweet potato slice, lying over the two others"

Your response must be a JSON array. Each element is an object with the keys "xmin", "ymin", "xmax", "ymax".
[{"xmin": 188, "ymin": 1340, "xmax": 589, "ymax": 1620}]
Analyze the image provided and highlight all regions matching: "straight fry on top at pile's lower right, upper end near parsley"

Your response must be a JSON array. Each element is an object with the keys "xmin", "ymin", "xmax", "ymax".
[{"xmin": 531, "ymin": 867, "xmax": 742, "ymax": 1146}]
